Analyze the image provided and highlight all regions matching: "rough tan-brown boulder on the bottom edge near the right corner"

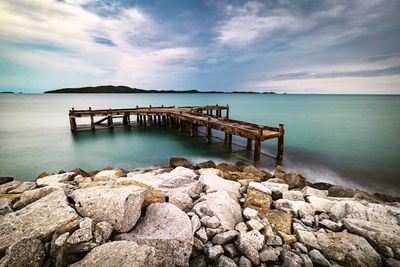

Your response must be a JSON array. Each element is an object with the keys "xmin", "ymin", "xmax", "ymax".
[{"xmin": 299, "ymin": 231, "xmax": 381, "ymax": 267}]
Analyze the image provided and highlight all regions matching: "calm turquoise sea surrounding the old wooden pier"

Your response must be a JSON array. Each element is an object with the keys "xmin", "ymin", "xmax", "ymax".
[{"xmin": 0, "ymin": 94, "xmax": 400, "ymax": 195}]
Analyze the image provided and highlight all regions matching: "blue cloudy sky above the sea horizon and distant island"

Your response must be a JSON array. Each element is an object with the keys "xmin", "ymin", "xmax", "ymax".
[{"xmin": 0, "ymin": 0, "xmax": 400, "ymax": 94}]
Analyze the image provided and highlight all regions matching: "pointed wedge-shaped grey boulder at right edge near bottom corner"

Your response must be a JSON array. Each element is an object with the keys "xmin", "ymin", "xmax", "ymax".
[{"xmin": 343, "ymin": 219, "xmax": 400, "ymax": 255}]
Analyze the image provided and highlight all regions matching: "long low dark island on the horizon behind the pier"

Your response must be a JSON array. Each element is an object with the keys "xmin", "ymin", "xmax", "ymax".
[{"xmin": 44, "ymin": 85, "xmax": 276, "ymax": 94}]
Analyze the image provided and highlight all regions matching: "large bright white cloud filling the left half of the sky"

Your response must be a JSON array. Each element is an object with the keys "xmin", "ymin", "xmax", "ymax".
[{"xmin": 0, "ymin": 0, "xmax": 197, "ymax": 90}]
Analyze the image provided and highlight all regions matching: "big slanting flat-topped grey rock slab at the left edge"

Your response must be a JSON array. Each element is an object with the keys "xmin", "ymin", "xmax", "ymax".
[{"xmin": 0, "ymin": 191, "xmax": 79, "ymax": 251}]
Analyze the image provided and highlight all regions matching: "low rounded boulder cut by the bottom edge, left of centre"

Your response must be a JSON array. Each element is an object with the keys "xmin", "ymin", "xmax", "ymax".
[{"xmin": 71, "ymin": 241, "xmax": 155, "ymax": 267}]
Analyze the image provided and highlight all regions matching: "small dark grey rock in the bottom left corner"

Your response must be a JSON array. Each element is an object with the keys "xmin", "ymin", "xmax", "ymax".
[{"xmin": 0, "ymin": 238, "xmax": 46, "ymax": 267}]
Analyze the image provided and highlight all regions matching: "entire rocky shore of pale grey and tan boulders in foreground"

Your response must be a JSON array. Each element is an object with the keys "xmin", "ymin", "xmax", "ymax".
[{"xmin": 0, "ymin": 158, "xmax": 400, "ymax": 267}]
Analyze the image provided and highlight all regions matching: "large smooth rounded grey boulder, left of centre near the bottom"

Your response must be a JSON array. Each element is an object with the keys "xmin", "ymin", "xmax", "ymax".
[{"xmin": 117, "ymin": 203, "xmax": 193, "ymax": 266}]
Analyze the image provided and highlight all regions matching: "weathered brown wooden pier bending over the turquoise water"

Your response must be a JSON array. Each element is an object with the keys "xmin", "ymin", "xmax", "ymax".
[{"xmin": 69, "ymin": 104, "xmax": 285, "ymax": 161}]
